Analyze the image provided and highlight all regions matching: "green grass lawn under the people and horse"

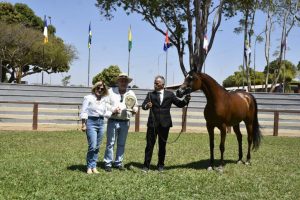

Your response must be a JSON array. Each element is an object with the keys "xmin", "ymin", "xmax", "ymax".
[{"xmin": 0, "ymin": 131, "xmax": 300, "ymax": 200}]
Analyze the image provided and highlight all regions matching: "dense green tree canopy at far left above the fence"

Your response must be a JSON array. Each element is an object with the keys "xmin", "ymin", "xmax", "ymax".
[{"xmin": 0, "ymin": 3, "xmax": 77, "ymax": 83}]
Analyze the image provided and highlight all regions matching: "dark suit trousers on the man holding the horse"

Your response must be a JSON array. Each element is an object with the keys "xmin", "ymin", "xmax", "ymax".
[{"xmin": 144, "ymin": 125, "xmax": 170, "ymax": 168}]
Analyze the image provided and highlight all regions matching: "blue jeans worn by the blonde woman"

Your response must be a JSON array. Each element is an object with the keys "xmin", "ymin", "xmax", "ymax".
[{"xmin": 86, "ymin": 117, "xmax": 104, "ymax": 169}]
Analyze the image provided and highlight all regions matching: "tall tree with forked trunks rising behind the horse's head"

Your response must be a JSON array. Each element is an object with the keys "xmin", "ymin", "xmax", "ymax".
[{"xmin": 96, "ymin": 0, "xmax": 226, "ymax": 75}]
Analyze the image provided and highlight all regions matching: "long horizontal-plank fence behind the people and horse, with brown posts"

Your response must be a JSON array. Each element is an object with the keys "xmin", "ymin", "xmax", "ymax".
[{"xmin": 0, "ymin": 84, "xmax": 300, "ymax": 136}]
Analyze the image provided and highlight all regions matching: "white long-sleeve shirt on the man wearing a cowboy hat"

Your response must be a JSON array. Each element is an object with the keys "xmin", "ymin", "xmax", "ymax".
[{"xmin": 108, "ymin": 87, "xmax": 138, "ymax": 120}]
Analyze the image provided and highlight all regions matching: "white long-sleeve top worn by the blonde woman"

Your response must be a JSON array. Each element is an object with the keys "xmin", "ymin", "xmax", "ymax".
[{"xmin": 80, "ymin": 94, "xmax": 112, "ymax": 119}]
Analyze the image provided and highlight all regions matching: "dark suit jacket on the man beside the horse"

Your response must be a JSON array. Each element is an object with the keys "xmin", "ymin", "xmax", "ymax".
[{"xmin": 142, "ymin": 90, "xmax": 187, "ymax": 127}]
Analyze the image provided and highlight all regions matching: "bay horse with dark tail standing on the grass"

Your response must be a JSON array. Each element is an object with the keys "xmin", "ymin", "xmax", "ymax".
[{"xmin": 176, "ymin": 71, "xmax": 261, "ymax": 170}]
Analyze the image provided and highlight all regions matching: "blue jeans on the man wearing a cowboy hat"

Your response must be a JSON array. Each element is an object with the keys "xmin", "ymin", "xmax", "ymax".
[{"xmin": 104, "ymin": 119, "xmax": 130, "ymax": 167}]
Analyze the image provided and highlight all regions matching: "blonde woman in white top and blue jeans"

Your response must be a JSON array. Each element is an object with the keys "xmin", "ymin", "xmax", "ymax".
[{"xmin": 80, "ymin": 81, "xmax": 112, "ymax": 174}]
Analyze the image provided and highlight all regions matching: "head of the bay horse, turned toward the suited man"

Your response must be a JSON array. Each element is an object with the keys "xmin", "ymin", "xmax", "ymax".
[{"xmin": 176, "ymin": 71, "xmax": 201, "ymax": 98}]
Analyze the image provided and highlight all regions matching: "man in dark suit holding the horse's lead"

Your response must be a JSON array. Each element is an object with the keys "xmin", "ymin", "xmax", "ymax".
[{"xmin": 142, "ymin": 76, "xmax": 190, "ymax": 172}]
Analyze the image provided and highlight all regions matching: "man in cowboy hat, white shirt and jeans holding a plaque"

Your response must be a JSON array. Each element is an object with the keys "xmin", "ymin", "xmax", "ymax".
[{"xmin": 104, "ymin": 73, "xmax": 138, "ymax": 172}]
